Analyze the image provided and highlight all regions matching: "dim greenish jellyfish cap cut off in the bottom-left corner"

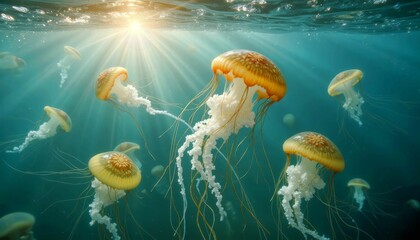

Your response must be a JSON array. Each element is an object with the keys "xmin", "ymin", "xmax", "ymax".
[{"xmin": 0, "ymin": 212, "xmax": 35, "ymax": 240}]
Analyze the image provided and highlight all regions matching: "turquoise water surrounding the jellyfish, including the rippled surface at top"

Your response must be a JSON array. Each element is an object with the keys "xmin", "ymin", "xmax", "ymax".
[{"xmin": 0, "ymin": 1, "xmax": 420, "ymax": 239}]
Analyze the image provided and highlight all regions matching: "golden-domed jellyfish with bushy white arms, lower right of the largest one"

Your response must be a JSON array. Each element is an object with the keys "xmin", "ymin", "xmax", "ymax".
[{"xmin": 277, "ymin": 132, "xmax": 344, "ymax": 239}]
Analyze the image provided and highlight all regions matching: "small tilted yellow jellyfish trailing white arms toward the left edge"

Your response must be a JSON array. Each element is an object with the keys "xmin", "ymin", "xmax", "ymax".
[{"xmin": 6, "ymin": 106, "xmax": 72, "ymax": 153}]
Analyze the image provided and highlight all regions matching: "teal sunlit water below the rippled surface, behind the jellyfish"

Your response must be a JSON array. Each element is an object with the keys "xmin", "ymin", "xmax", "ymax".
[{"xmin": 0, "ymin": 0, "xmax": 420, "ymax": 239}]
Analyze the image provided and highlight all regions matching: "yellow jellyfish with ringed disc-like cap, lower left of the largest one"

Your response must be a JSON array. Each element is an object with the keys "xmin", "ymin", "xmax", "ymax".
[{"xmin": 88, "ymin": 151, "xmax": 141, "ymax": 240}]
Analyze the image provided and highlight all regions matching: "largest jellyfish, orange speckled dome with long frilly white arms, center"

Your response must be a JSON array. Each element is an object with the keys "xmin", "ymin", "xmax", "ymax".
[{"xmin": 176, "ymin": 50, "xmax": 286, "ymax": 221}]
